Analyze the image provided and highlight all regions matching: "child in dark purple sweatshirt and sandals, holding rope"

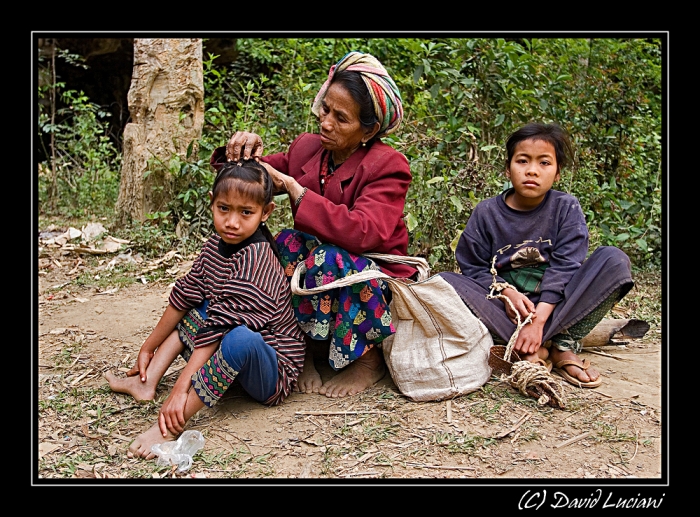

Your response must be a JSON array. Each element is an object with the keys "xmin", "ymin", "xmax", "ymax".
[{"xmin": 441, "ymin": 123, "xmax": 634, "ymax": 388}]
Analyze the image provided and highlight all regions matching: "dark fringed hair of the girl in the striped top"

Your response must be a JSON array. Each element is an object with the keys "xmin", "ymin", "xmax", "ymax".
[{"xmin": 209, "ymin": 158, "xmax": 282, "ymax": 262}]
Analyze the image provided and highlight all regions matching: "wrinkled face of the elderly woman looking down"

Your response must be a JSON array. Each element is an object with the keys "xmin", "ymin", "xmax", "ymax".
[{"xmin": 319, "ymin": 83, "xmax": 366, "ymax": 162}]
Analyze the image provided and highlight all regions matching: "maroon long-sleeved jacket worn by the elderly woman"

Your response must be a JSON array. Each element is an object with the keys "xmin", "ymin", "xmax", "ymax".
[{"xmin": 211, "ymin": 133, "xmax": 416, "ymax": 278}]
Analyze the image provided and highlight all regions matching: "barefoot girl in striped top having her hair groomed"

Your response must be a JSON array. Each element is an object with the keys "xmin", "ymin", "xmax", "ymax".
[{"xmin": 105, "ymin": 160, "xmax": 305, "ymax": 459}]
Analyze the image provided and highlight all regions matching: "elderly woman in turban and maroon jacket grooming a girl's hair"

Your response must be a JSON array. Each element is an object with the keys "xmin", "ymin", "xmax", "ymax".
[{"xmin": 211, "ymin": 52, "xmax": 416, "ymax": 397}]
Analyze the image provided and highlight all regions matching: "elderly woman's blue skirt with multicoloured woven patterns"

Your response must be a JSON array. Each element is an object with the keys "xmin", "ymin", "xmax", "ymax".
[{"xmin": 275, "ymin": 229, "xmax": 395, "ymax": 370}]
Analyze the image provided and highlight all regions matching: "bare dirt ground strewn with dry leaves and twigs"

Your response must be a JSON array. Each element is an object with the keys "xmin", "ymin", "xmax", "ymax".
[{"xmin": 34, "ymin": 245, "xmax": 667, "ymax": 488}]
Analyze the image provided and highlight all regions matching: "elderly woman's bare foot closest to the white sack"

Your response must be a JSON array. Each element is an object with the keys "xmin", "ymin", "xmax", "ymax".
[{"xmin": 318, "ymin": 346, "xmax": 386, "ymax": 398}]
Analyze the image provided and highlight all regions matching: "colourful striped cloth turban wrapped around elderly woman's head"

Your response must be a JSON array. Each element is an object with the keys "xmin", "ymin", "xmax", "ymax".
[{"xmin": 311, "ymin": 52, "xmax": 403, "ymax": 136}]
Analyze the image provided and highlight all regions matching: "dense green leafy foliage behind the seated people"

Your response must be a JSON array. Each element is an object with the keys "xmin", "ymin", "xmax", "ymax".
[{"xmin": 40, "ymin": 37, "xmax": 663, "ymax": 271}]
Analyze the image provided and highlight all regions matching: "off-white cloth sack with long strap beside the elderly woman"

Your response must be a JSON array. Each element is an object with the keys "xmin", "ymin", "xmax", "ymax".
[{"xmin": 291, "ymin": 253, "xmax": 493, "ymax": 402}]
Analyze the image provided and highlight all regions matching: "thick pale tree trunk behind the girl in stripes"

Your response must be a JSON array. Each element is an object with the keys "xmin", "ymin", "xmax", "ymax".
[{"xmin": 116, "ymin": 38, "xmax": 204, "ymax": 225}]
